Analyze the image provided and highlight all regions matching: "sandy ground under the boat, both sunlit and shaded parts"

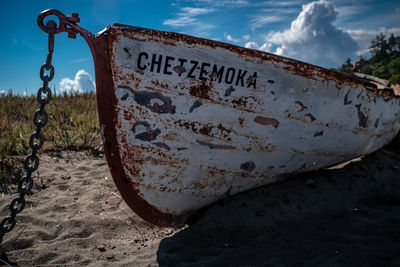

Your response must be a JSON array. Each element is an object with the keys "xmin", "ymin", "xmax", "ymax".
[{"xmin": 0, "ymin": 150, "xmax": 400, "ymax": 266}]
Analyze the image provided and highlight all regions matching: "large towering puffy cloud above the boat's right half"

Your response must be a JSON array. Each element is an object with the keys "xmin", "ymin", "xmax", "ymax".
[{"xmin": 253, "ymin": 0, "xmax": 358, "ymax": 67}]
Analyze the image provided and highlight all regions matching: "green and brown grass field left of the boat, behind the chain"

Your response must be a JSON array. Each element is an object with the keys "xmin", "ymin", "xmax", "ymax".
[{"xmin": 0, "ymin": 93, "xmax": 103, "ymax": 189}]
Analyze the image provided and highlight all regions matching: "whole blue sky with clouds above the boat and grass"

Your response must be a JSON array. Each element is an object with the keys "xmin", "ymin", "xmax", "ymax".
[{"xmin": 0, "ymin": 0, "xmax": 400, "ymax": 94}]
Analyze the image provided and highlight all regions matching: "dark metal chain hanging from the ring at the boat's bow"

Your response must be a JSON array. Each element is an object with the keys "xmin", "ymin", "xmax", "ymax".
[{"xmin": 0, "ymin": 20, "xmax": 57, "ymax": 244}]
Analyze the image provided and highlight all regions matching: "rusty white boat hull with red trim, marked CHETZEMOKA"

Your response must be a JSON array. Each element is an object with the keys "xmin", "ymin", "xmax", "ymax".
[{"xmin": 47, "ymin": 13, "xmax": 400, "ymax": 225}]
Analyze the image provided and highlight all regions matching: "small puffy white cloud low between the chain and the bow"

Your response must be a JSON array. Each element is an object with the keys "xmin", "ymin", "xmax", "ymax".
[{"xmin": 60, "ymin": 70, "xmax": 95, "ymax": 94}]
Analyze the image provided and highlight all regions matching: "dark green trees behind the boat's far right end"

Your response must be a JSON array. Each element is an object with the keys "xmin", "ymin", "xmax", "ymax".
[{"xmin": 338, "ymin": 33, "xmax": 400, "ymax": 81}]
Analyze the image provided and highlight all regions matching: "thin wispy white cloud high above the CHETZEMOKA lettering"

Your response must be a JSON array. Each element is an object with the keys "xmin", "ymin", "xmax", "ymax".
[{"xmin": 163, "ymin": 7, "xmax": 215, "ymax": 35}]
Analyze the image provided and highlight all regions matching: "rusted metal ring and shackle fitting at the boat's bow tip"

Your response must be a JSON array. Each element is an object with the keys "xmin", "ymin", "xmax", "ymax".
[{"xmin": 37, "ymin": 9, "xmax": 93, "ymax": 41}]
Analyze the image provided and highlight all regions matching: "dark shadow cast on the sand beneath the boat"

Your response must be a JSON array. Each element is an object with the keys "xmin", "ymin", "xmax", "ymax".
[{"xmin": 157, "ymin": 151, "xmax": 400, "ymax": 266}]
